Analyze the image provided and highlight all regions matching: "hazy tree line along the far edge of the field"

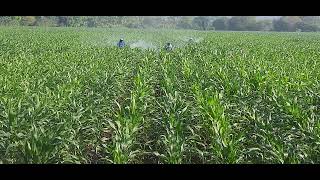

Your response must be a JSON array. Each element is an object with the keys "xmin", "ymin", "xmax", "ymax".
[{"xmin": 0, "ymin": 16, "xmax": 320, "ymax": 32}]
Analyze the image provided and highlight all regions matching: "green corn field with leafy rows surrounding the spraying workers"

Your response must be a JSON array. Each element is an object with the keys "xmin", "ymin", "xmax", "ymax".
[{"xmin": 0, "ymin": 27, "xmax": 320, "ymax": 164}]
